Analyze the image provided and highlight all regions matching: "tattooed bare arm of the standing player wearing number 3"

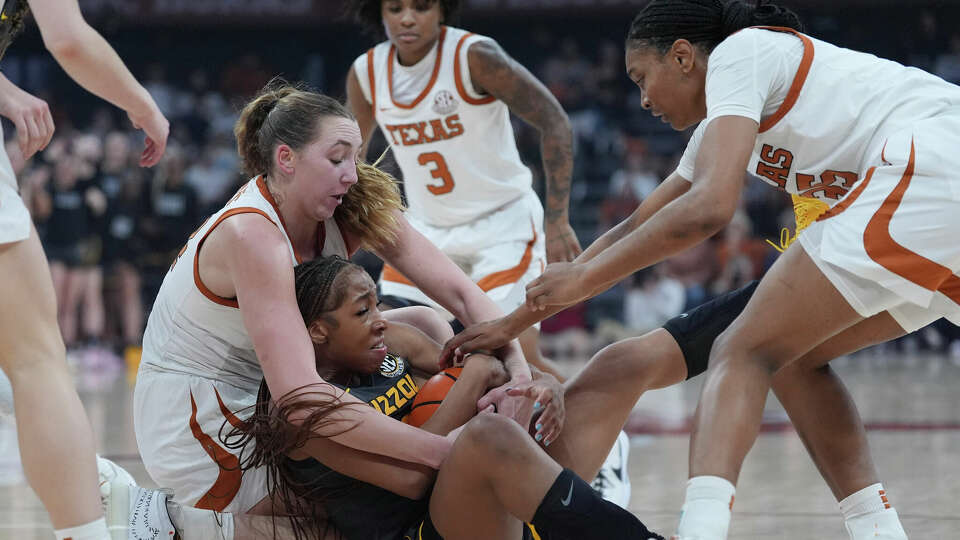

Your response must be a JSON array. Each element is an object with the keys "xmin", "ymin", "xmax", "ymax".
[{"xmin": 467, "ymin": 40, "xmax": 580, "ymax": 262}]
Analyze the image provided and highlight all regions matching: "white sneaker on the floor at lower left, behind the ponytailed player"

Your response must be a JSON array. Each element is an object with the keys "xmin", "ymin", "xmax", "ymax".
[{"xmin": 100, "ymin": 481, "xmax": 177, "ymax": 540}]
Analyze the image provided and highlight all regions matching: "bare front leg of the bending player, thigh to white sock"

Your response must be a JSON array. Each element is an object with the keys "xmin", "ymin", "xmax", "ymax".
[{"xmin": 690, "ymin": 246, "xmax": 862, "ymax": 484}]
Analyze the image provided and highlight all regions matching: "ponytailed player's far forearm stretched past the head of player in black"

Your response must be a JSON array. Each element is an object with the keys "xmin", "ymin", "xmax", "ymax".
[{"xmin": 377, "ymin": 216, "xmax": 530, "ymax": 381}]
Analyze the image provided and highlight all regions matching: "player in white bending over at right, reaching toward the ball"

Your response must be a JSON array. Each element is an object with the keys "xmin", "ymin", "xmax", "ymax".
[{"xmin": 446, "ymin": 0, "xmax": 960, "ymax": 540}]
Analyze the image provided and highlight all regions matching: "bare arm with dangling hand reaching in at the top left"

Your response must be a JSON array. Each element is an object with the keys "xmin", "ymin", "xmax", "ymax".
[{"xmin": 29, "ymin": 0, "xmax": 170, "ymax": 167}]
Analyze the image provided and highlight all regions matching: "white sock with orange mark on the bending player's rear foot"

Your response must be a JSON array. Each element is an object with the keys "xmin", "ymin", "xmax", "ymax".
[{"xmin": 840, "ymin": 483, "xmax": 907, "ymax": 540}]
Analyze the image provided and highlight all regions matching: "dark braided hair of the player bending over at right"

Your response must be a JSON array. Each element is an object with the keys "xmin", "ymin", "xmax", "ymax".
[{"xmin": 627, "ymin": 0, "xmax": 803, "ymax": 54}]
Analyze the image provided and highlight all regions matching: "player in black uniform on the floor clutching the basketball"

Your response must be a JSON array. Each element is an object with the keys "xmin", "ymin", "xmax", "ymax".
[{"xmin": 234, "ymin": 257, "xmax": 660, "ymax": 540}]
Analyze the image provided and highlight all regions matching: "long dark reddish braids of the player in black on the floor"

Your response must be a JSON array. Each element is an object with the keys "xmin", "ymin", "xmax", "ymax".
[{"xmin": 221, "ymin": 255, "xmax": 364, "ymax": 540}]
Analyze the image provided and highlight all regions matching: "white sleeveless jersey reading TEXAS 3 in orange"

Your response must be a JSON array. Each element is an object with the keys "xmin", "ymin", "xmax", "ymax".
[{"xmin": 353, "ymin": 26, "xmax": 532, "ymax": 227}]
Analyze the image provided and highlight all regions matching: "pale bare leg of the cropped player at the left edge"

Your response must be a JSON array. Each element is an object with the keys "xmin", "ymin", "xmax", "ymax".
[{"xmin": 0, "ymin": 230, "xmax": 103, "ymax": 529}]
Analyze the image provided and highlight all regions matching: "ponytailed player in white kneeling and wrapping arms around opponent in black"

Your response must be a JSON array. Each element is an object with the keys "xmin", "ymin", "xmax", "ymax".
[{"xmin": 134, "ymin": 80, "xmax": 530, "ymax": 536}]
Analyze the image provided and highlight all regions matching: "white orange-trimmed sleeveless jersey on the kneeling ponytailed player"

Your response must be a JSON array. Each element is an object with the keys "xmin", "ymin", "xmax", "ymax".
[{"xmin": 141, "ymin": 176, "xmax": 348, "ymax": 394}]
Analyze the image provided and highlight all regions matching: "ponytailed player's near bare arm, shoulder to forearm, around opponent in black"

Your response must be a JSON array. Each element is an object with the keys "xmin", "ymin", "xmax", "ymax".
[{"xmin": 221, "ymin": 214, "xmax": 451, "ymax": 468}]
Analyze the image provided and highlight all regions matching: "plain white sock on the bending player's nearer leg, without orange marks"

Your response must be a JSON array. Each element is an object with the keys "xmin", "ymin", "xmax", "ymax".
[{"xmin": 677, "ymin": 476, "xmax": 737, "ymax": 540}]
